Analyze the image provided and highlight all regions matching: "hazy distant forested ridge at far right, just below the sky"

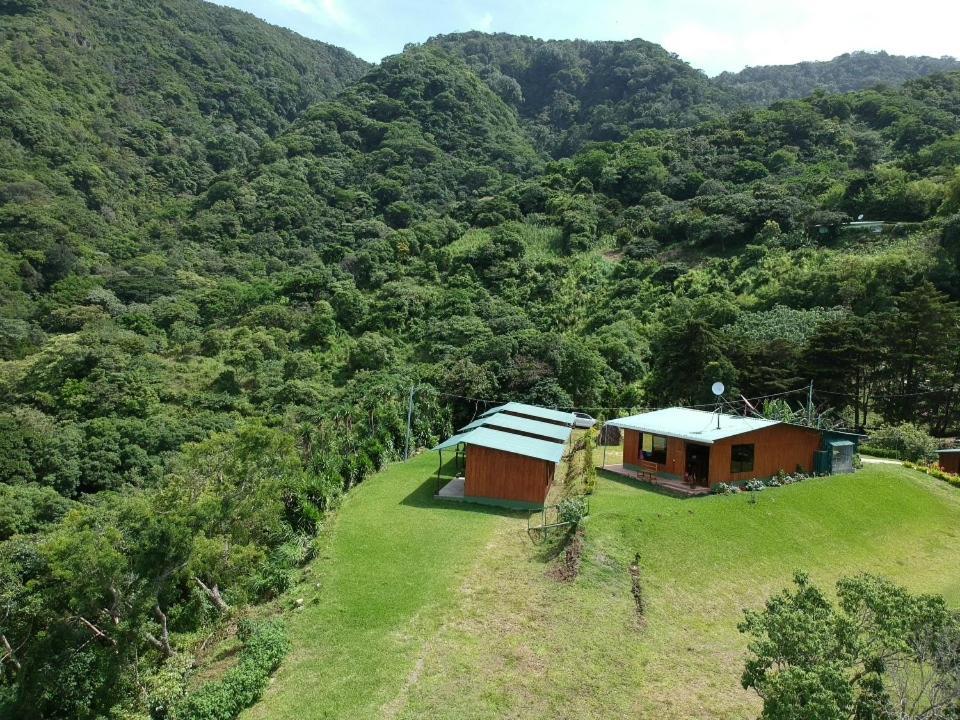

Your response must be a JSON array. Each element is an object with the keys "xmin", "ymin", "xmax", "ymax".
[{"xmin": 713, "ymin": 51, "xmax": 960, "ymax": 105}]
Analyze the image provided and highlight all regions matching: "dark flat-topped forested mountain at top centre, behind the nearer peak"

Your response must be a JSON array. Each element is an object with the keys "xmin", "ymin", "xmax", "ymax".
[{"xmin": 426, "ymin": 32, "xmax": 728, "ymax": 155}]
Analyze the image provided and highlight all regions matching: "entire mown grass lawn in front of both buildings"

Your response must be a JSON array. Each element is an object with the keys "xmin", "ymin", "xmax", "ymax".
[{"xmin": 244, "ymin": 457, "xmax": 960, "ymax": 720}]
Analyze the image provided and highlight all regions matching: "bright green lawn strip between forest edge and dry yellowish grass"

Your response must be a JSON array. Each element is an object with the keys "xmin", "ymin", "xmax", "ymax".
[{"xmin": 244, "ymin": 453, "xmax": 504, "ymax": 720}]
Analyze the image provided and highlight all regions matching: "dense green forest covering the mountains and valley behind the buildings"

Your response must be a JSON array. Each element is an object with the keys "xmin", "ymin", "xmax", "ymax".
[{"xmin": 0, "ymin": 0, "xmax": 960, "ymax": 718}]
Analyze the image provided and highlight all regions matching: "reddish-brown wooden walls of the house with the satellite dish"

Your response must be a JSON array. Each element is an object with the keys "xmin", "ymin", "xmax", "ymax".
[{"xmin": 623, "ymin": 425, "xmax": 820, "ymax": 485}]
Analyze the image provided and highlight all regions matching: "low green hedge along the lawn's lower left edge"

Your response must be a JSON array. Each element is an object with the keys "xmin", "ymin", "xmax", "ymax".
[{"xmin": 172, "ymin": 620, "xmax": 290, "ymax": 720}]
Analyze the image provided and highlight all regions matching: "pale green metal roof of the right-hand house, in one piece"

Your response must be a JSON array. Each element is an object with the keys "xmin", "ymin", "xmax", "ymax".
[{"xmin": 609, "ymin": 407, "xmax": 780, "ymax": 445}]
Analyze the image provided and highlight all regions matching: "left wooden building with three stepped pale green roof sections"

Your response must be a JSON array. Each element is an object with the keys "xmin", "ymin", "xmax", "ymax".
[{"xmin": 434, "ymin": 403, "xmax": 573, "ymax": 508}]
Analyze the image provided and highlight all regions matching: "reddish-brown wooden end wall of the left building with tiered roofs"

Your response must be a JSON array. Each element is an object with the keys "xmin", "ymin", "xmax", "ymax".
[{"xmin": 464, "ymin": 445, "xmax": 556, "ymax": 505}]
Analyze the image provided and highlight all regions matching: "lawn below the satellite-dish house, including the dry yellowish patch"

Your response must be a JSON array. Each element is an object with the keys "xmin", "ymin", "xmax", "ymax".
[{"xmin": 380, "ymin": 464, "xmax": 960, "ymax": 720}]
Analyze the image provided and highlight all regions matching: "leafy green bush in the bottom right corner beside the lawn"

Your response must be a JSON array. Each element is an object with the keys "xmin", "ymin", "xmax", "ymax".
[{"xmin": 739, "ymin": 573, "xmax": 960, "ymax": 720}]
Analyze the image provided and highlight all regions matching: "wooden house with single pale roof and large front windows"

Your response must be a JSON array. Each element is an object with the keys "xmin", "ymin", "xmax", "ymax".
[{"xmin": 610, "ymin": 408, "xmax": 823, "ymax": 487}]
